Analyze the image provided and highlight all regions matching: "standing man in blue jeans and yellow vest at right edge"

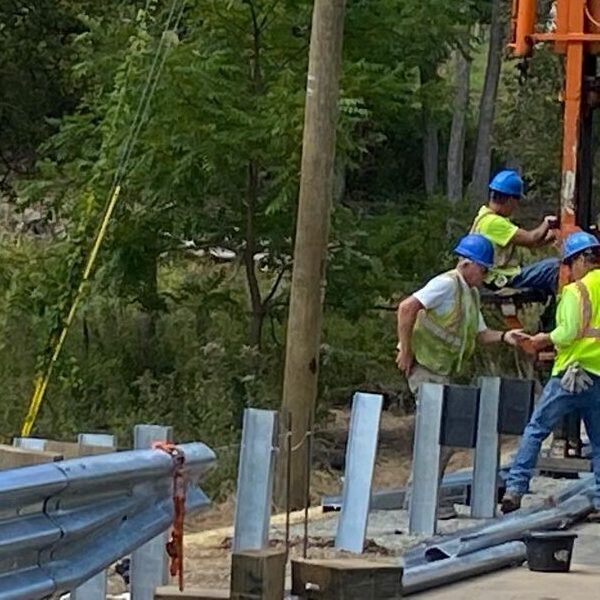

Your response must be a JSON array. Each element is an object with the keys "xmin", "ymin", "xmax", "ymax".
[{"xmin": 502, "ymin": 232, "xmax": 600, "ymax": 513}]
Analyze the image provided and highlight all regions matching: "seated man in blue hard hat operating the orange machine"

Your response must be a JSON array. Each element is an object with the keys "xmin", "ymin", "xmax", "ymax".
[{"xmin": 471, "ymin": 170, "xmax": 559, "ymax": 297}]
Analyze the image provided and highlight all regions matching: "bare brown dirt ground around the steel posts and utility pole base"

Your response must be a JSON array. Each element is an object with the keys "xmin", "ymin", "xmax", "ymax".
[{"xmin": 109, "ymin": 410, "xmax": 514, "ymax": 594}]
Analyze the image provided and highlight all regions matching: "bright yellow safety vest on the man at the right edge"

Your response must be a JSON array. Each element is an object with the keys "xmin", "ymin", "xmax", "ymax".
[{"xmin": 552, "ymin": 269, "xmax": 600, "ymax": 375}]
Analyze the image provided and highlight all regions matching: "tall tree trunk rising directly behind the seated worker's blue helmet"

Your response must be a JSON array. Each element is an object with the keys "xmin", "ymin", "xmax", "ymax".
[{"xmin": 469, "ymin": 0, "xmax": 505, "ymax": 202}]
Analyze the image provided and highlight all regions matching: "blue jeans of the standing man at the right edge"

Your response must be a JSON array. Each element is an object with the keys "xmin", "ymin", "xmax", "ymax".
[{"xmin": 506, "ymin": 374, "xmax": 600, "ymax": 509}]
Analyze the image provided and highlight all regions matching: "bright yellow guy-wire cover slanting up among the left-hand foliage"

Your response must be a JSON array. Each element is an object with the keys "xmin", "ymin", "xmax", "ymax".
[{"xmin": 21, "ymin": 185, "xmax": 121, "ymax": 437}]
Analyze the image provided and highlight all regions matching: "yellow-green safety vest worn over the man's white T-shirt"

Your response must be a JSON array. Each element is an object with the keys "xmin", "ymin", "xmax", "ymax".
[{"xmin": 412, "ymin": 270, "xmax": 480, "ymax": 375}]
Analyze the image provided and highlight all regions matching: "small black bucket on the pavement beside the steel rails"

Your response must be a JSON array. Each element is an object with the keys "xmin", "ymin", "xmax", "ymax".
[{"xmin": 524, "ymin": 531, "xmax": 577, "ymax": 573}]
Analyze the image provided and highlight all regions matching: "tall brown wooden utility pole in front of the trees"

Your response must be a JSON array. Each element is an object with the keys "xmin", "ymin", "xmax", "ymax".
[{"xmin": 277, "ymin": 0, "xmax": 346, "ymax": 509}]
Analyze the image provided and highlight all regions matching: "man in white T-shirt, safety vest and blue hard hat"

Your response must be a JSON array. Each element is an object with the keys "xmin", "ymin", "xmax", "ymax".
[{"xmin": 396, "ymin": 234, "xmax": 520, "ymax": 518}]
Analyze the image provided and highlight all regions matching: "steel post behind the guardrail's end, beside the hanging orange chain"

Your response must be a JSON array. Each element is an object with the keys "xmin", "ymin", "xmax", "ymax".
[{"xmin": 130, "ymin": 425, "xmax": 173, "ymax": 600}]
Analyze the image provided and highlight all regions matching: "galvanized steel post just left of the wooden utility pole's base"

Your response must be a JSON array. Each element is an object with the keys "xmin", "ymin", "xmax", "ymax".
[{"xmin": 232, "ymin": 408, "xmax": 278, "ymax": 552}]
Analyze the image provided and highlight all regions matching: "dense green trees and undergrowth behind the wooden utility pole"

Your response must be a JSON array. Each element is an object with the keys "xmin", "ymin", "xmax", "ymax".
[{"xmin": 0, "ymin": 0, "xmax": 550, "ymax": 500}]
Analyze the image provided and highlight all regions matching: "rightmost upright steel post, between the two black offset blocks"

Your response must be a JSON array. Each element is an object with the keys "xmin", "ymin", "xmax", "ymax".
[{"xmin": 471, "ymin": 377, "xmax": 501, "ymax": 519}]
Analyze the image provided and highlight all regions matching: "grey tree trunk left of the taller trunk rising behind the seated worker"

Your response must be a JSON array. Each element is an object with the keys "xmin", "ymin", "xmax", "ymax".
[{"xmin": 446, "ymin": 49, "xmax": 471, "ymax": 203}]
